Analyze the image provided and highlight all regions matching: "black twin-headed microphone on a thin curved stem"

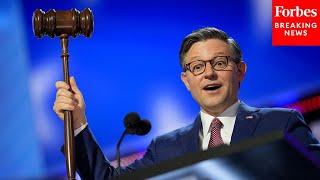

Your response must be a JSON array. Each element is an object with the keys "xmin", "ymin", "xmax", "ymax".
[{"xmin": 117, "ymin": 112, "xmax": 151, "ymax": 167}]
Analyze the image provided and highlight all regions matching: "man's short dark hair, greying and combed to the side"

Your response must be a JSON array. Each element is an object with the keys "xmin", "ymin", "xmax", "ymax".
[{"xmin": 179, "ymin": 27, "xmax": 242, "ymax": 67}]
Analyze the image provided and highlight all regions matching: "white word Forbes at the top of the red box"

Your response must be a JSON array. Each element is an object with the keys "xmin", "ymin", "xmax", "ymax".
[{"xmin": 275, "ymin": 6, "xmax": 318, "ymax": 17}]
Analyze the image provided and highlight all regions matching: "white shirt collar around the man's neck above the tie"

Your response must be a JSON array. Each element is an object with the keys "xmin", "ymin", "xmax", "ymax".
[{"xmin": 200, "ymin": 100, "xmax": 240, "ymax": 135}]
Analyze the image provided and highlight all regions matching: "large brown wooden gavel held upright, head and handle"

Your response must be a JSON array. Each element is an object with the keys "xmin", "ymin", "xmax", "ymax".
[{"xmin": 32, "ymin": 8, "xmax": 93, "ymax": 179}]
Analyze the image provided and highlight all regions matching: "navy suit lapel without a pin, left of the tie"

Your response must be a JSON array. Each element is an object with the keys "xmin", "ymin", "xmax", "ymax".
[{"xmin": 180, "ymin": 115, "xmax": 201, "ymax": 153}]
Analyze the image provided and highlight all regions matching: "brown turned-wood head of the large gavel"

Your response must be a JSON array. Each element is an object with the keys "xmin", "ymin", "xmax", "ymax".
[{"xmin": 32, "ymin": 8, "xmax": 93, "ymax": 38}]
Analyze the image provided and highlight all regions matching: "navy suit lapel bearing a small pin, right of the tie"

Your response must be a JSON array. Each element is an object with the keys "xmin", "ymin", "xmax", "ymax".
[{"xmin": 231, "ymin": 102, "xmax": 260, "ymax": 144}]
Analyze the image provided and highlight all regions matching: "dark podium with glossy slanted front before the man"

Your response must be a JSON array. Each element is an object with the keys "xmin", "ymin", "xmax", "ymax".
[{"xmin": 118, "ymin": 132, "xmax": 320, "ymax": 180}]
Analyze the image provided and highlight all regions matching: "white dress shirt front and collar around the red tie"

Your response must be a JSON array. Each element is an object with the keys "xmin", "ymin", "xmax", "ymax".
[{"xmin": 199, "ymin": 101, "xmax": 240, "ymax": 150}]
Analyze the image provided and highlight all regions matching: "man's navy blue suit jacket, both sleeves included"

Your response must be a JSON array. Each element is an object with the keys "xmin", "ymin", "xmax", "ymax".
[{"xmin": 75, "ymin": 102, "xmax": 320, "ymax": 179}]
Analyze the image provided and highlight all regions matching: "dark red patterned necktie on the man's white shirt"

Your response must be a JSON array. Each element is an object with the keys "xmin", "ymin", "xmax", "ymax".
[{"xmin": 208, "ymin": 118, "xmax": 223, "ymax": 149}]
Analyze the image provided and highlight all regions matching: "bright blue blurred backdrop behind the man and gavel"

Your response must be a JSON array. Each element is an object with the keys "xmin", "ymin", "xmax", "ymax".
[{"xmin": 0, "ymin": 0, "xmax": 320, "ymax": 178}]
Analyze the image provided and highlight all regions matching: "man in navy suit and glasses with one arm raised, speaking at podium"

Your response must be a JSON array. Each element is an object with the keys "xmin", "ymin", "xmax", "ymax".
[{"xmin": 53, "ymin": 28, "xmax": 320, "ymax": 179}]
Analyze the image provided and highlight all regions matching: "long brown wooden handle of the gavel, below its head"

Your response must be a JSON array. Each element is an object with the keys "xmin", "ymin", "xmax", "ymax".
[{"xmin": 60, "ymin": 34, "xmax": 75, "ymax": 180}]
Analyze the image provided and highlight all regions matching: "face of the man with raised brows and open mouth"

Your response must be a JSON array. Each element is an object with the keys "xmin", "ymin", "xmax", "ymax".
[{"xmin": 181, "ymin": 39, "xmax": 246, "ymax": 116}]
